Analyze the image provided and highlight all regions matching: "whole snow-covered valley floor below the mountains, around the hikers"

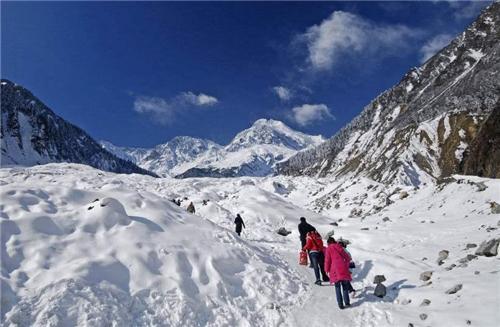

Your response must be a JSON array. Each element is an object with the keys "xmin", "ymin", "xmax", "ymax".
[{"xmin": 0, "ymin": 164, "xmax": 500, "ymax": 326}]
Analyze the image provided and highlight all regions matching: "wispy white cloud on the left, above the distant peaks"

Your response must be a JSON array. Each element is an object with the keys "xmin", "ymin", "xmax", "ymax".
[{"xmin": 134, "ymin": 91, "xmax": 219, "ymax": 124}]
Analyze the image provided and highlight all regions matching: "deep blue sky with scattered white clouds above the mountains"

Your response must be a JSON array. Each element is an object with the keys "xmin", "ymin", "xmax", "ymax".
[{"xmin": 1, "ymin": 1, "xmax": 487, "ymax": 147}]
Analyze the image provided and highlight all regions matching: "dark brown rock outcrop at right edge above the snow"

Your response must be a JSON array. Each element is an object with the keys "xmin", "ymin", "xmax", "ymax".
[{"xmin": 461, "ymin": 102, "xmax": 500, "ymax": 178}]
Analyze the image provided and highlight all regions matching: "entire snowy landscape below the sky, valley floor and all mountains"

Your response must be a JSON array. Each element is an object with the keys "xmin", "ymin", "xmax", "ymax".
[{"xmin": 0, "ymin": 2, "xmax": 500, "ymax": 327}]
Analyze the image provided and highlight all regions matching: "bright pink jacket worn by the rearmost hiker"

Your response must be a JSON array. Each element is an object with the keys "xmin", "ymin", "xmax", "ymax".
[{"xmin": 325, "ymin": 243, "xmax": 352, "ymax": 284}]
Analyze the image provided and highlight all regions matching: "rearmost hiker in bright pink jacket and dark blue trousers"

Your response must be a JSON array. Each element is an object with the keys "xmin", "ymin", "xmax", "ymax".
[{"xmin": 325, "ymin": 237, "xmax": 352, "ymax": 309}]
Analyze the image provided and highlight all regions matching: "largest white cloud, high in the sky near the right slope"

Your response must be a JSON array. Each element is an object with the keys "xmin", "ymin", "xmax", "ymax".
[{"xmin": 297, "ymin": 11, "xmax": 420, "ymax": 70}]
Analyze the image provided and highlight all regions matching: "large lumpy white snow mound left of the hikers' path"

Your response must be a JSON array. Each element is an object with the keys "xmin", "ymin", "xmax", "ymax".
[{"xmin": 0, "ymin": 164, "xmax": 305, "ymax": 326}]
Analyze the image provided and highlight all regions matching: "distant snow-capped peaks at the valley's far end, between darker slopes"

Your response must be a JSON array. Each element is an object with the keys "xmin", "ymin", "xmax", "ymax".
[{"xmin": 101, "ymin": 119, "xmax": 324, "ymax": 178}]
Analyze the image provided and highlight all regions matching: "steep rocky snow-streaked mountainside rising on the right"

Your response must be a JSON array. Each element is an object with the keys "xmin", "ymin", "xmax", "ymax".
[{"xmin": 277, "ymin": 2, "xmax": 500, "ymax": 185}]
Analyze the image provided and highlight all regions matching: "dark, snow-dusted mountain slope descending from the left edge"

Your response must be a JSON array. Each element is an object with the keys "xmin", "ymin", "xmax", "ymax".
[{"xmin": 0, "ymin": 79, "xmax": 155, "ymax": 176}]
